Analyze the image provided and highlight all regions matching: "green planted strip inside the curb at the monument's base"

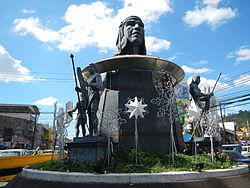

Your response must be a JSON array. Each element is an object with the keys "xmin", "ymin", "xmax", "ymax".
[{"xmin": 28, "ymin": 151, "xmax": 235, "ymax": 173}]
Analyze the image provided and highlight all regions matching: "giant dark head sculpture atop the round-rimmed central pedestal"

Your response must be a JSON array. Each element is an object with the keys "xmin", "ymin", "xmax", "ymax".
[{"xmin": 115, "ymin": 16, "xmax": 146, "ymax": 55}]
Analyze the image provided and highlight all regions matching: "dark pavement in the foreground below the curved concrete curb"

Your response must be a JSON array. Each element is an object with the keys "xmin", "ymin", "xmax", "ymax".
[{"xmin": 6, "ymin": 173, "xmax": 250, "ymax": 188}]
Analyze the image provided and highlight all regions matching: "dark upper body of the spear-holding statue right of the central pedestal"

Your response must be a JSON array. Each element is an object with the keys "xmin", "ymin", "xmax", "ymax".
[{"xmin": 189, "ymin": 75, "xmax": 213, "ymax": 111}]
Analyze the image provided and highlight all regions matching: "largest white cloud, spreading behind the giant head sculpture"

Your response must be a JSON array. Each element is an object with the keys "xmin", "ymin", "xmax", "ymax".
[{"xmin": 14, "ymin": 0, "xmax": 172, "ymax": 52}]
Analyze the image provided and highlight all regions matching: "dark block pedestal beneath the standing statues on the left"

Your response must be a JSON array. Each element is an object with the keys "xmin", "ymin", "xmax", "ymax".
[{"xmin": 65, "ymin": 136, "xmax": 107, "ymax": 163}]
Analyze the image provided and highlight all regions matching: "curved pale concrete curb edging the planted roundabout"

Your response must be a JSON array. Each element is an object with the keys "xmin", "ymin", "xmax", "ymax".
[{"xmin": 22, "ymin": 165, "xmax": 249, "ymax": 184}]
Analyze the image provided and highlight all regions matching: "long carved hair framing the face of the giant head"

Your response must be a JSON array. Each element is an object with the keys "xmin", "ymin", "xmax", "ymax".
[{"xmin": 115, "ymin": 16, "xmax": 146, "ymax": 55}]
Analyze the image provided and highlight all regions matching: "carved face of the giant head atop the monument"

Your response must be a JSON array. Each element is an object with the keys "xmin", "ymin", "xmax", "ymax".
[{"xmin": 124, "ymin": 18, "xmax": 144, "ymax": 45}]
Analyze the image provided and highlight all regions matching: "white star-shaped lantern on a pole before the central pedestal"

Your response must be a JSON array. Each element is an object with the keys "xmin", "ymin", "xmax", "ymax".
[{"xmin": 125, "ymin": 97, "xmax": 148, "ymax": 119}]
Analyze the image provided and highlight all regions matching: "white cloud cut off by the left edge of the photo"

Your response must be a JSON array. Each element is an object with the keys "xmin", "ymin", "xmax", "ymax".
[{"xmin": 0, "ymin": 45, "xmax": 35, "ymax": 82}]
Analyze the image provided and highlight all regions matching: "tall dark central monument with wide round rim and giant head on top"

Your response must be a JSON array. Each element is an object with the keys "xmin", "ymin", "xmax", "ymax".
[{"xmin": 66, "ymin": 16, "xmax": 184, "ymax": 163}]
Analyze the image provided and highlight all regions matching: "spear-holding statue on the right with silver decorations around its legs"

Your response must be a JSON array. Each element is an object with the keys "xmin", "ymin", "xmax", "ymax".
[{"xmin": 188, "ymin": 73, "xmax": 221, "ymax": 156}]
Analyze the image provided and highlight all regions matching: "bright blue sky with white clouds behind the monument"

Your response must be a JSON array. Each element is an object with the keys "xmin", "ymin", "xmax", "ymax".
[{"xmin": 0, "ymin": 0, "xmax": 250, "ymax": 137}]
